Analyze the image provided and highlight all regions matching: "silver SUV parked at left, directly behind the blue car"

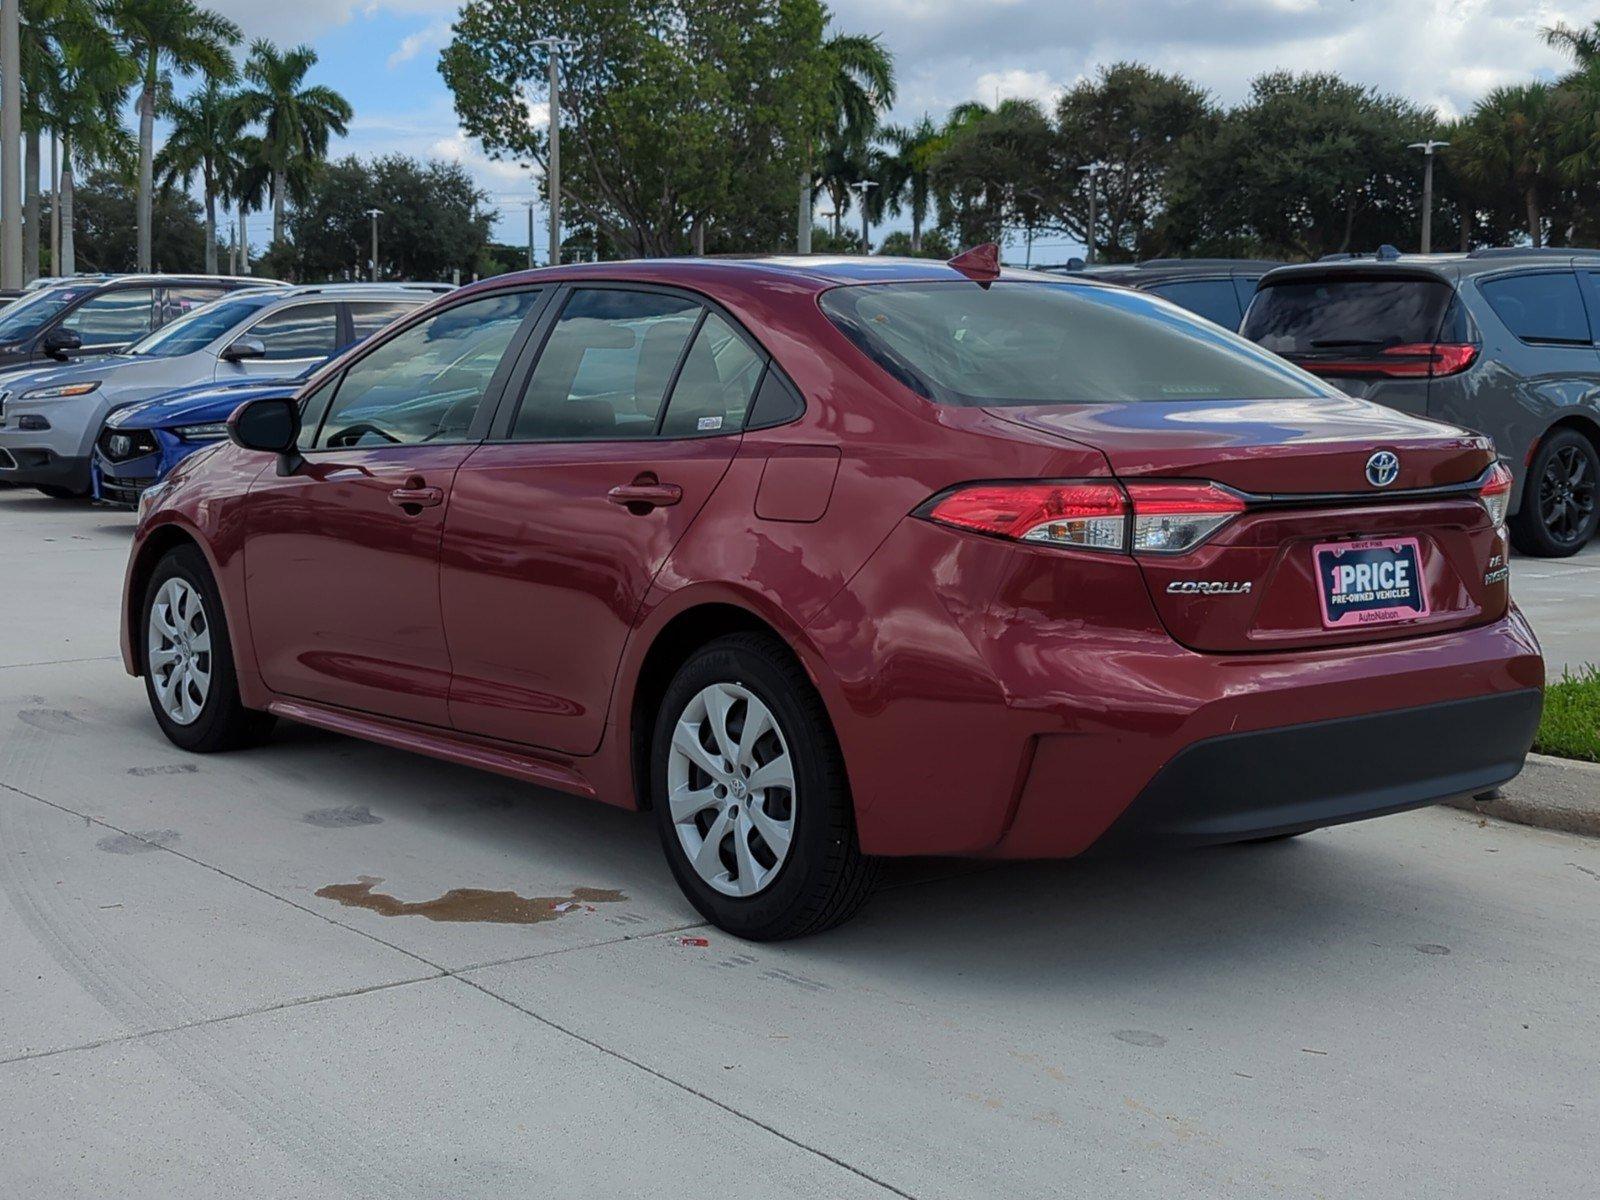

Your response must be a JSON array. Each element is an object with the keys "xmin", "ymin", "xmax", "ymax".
[{"xmin": 0, "ymin": 283, "xmax": 450, "ymax": 498}]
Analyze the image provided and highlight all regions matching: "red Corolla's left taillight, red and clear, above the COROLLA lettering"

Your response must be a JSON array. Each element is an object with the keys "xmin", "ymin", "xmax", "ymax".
[{"xmin": 917, "ymin": 480, "xmax": 1245, "ymax": 554}]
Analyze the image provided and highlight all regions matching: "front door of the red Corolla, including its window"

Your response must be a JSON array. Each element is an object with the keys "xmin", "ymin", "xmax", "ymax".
[{"xmin": 245, "ymin": 291, "xmax": 538, "ymax": 726}]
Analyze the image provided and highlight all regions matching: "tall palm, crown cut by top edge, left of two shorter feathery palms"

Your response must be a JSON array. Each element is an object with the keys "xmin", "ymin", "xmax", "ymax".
[{"xmin": 106, "ymin": 0, "xmax": 243, "ymax": 270}]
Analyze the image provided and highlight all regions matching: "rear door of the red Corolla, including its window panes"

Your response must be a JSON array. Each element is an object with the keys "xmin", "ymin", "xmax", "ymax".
[{"xmin": 442, "ymin": 285, "xmax": 765, "ymax": 754}]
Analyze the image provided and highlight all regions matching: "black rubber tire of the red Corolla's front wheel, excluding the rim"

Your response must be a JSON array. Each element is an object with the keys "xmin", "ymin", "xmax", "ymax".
[{"xmin": 138, "ymin": 546, "xmax": 275, "ymax": 754}]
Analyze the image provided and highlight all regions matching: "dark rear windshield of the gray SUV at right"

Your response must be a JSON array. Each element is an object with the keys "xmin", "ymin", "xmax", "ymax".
[{"xmin": 1240, "ymin": 277, "xmax": 1454, "ymax": 355}]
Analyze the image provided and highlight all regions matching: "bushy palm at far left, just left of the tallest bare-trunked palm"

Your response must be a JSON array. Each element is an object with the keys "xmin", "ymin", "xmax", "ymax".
[{"xmin": 38, "ymin": 3, "xmax": 139, "ymax": 275}]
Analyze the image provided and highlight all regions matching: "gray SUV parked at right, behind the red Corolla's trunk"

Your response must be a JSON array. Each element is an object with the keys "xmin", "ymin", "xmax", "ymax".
[{"xmin": 1243, "ymin": 248, "xmax": 1600, "ymax": 557}]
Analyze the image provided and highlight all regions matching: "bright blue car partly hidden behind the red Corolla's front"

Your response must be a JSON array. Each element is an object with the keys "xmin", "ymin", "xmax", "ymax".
[{"xmin": 90, "ymin": 358, "xmax": 328, "ymax": 507}]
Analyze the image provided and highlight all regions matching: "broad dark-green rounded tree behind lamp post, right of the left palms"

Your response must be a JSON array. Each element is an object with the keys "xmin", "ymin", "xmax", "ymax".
[{"xmin": 288, "ymin": 154, "xmax": 489, "ymax": 280}]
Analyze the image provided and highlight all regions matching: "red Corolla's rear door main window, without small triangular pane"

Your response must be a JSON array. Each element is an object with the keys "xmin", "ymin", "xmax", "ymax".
[{"xmin": 512, "ymin": 288, "xmax": 697, "ymax": 442}]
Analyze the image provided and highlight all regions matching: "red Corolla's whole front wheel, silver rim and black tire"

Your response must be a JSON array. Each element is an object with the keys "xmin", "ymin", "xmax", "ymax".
[{"xmin": 139, "ymin": 546, "xmax": 272, "ymax": 754}]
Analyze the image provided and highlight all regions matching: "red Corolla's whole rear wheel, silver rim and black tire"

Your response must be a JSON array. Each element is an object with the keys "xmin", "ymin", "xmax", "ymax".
[{"xmin": 650, "ymin": 634, "xmax": 877, "ymax": 941}]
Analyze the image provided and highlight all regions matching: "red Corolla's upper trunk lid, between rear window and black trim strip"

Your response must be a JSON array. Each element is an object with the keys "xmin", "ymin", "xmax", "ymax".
[{"xmin": 986, "ymin": 397, "xmax": 1493, "ymax": 494}]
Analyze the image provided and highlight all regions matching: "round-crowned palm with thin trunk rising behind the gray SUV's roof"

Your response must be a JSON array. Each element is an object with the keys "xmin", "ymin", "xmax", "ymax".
[{"xmin": 1453, "ymin": 83, "xmax": 1560, "ymax": 246}]
